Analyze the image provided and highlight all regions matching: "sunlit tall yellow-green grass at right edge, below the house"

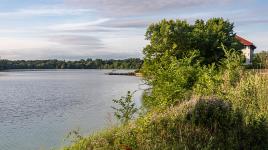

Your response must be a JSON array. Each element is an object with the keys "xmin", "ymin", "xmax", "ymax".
[{"xmin": 224, "ymin": 73, "xmax": 268, "ymax": 119}]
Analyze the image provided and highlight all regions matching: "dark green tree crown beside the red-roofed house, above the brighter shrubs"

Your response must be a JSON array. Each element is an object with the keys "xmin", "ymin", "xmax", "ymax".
[{"xmin": 143, "ymin": 18, "xmax": 242, "ymax": 64}]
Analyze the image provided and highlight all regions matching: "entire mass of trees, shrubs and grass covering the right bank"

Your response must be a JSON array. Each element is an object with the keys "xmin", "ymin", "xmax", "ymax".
[{"xmin": 64, "ymin": 18, "xmax": 268, "ymax": 150}]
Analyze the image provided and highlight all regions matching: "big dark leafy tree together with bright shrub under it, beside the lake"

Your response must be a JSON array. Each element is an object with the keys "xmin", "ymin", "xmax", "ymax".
[{"xmin": 142, "ymin": 18, "xmax": 242, "ymax": 107}]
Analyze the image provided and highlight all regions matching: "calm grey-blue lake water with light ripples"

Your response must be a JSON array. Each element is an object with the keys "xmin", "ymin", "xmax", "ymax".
[{"xmin": 0, "ymin": 70, "xmax": 144, "ymax": 150}]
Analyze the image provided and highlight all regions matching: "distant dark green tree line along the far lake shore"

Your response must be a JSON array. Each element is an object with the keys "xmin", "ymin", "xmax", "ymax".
[{"xmin": 0, "ymin": 58, "xmax": 143, "ymax": 70}]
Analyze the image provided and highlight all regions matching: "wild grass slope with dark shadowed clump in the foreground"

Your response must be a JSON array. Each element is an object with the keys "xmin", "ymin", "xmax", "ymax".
[{"xmin": 64, "ymin": 96, "xmax": 268, "ymax": 150}]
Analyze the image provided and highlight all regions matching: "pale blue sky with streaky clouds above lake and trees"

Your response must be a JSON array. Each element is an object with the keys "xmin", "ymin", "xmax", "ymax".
[{"xmin": 0, "ymin": 0, "xmax": 268, "ymax": 60}]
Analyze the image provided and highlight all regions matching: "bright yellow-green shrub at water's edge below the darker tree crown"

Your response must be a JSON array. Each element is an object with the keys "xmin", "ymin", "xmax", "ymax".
[{"xmin": 143, "ymin": 51, "xmax": 200, "ymax": 108}]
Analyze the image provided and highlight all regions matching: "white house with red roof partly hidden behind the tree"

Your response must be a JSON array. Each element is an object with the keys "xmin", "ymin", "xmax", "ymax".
[{"xmin": 235, "ymin": 35, "xmax": 256, "ymax": 65}]
